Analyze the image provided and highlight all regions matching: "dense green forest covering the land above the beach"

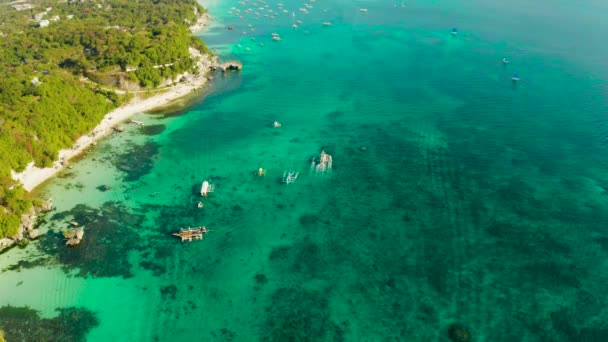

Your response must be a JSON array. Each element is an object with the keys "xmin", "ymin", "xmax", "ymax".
[{"xmin": 0, "ymin": 0, "xmax": 210, "ymax": 238}]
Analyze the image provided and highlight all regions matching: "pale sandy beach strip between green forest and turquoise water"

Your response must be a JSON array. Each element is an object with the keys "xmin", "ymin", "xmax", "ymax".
[{"xmin": 11, "ymin": 17, "xmax": 219, "ymax": 192}]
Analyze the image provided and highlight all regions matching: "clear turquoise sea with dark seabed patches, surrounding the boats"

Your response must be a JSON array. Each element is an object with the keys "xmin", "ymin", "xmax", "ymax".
[{"xmin": 0, "ymin": 0, "xmax": 608, "ymax": 342}]
